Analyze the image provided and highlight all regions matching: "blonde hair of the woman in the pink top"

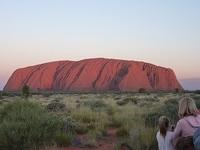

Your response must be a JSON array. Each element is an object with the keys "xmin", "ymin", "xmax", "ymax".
[{"xmin": 178, "ymin": 97, "xmax": 199, "ymax": 118}]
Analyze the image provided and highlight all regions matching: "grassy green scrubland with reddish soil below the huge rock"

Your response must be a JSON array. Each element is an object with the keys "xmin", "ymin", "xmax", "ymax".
[{"xmin": 0, "ymin": 93, "xmax": 200, "ymax": 150}]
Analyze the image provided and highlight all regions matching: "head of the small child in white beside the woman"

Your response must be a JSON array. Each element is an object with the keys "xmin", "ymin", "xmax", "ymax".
[{"xmin": 158, "ymin": 116, "xmax": 170, "ymax": 137}]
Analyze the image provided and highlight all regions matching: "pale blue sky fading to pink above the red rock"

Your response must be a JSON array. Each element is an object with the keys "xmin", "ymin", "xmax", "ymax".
[{"xmin": 0, "ymin": 0, "xmax": 200, "ymax": 89}]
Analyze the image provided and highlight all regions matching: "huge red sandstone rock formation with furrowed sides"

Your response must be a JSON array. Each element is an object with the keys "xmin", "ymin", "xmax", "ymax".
[{"xmin": 4, "ymin": 58, "xmax": 182, "ymax": 92}]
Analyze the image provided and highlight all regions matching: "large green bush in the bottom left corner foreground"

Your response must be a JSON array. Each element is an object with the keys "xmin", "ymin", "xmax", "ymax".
[{"xmin": 0, "ymin": 101, "xmax": 63, "ymax": 150}]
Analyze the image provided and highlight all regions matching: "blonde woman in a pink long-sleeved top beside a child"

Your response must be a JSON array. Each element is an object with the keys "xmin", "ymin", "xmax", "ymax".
[{"xmin": 173, "ymin": 97, "xmax": 200, "ymax": 150}]
